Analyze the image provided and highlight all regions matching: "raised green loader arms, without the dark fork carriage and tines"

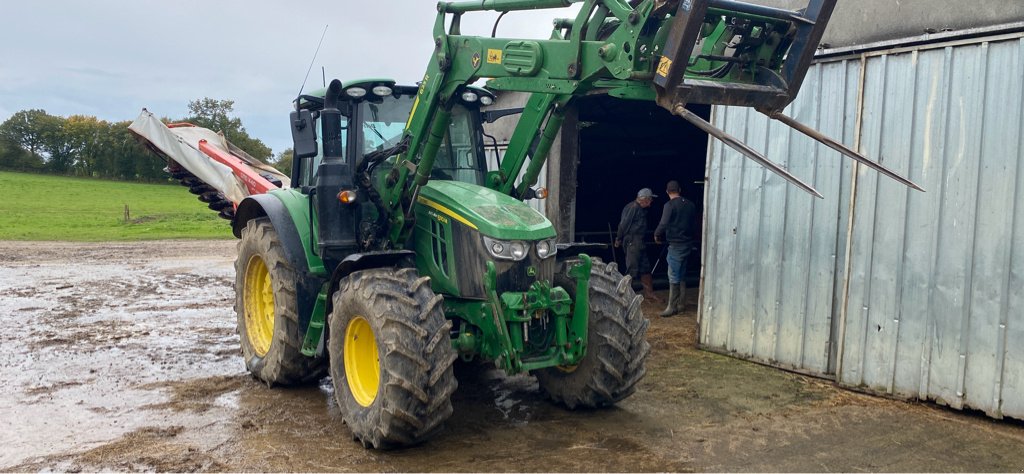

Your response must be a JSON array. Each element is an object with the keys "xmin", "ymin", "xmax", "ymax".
[{"xmin": 383, "ymin": 0, "xmax": 649, "ymax": 247}]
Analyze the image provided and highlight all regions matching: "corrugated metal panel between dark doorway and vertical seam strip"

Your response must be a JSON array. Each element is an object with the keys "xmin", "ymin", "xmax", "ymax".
[{"xmin": 700, "ymin": 61, "xmax": 860, "ymax": 374}]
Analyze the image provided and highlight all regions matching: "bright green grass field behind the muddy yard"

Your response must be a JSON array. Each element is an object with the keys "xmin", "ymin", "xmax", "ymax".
[{"xmin": 0, "ymin": 171, "xmax": 233, "ymax": 242}]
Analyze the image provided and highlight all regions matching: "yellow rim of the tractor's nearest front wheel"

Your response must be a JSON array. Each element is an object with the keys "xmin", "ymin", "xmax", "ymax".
[{"xmin": 345, "ymin": 316, "xmax": 381, "ymax": 406}]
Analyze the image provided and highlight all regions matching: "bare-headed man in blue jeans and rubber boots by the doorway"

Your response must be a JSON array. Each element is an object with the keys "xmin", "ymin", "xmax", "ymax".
[{"xmin": 654, "ymin": 180, "xmax": 696, "ymax": 317}]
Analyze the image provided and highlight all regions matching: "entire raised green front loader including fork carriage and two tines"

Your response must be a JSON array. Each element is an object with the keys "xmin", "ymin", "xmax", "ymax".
[{"xmin": 385, "ymin": 0, "xmax": 920, "ymax": 246}]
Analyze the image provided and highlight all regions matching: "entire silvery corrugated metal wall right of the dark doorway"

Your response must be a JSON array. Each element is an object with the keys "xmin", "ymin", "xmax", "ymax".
[{"xmin": 700, "ymin": 35, "xmax": 1024, "ymax": 418}]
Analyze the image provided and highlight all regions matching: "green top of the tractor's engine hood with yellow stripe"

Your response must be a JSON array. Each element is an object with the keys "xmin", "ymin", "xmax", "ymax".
[{"xmin": 417, "ymin": 180, "xmax": 555, "ymax": 241}]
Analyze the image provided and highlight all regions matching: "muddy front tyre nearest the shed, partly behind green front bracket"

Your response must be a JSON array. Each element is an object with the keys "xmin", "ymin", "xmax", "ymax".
[{"xmin": 535, "ymin": 258, "xmax": 650, "ymax": 410}]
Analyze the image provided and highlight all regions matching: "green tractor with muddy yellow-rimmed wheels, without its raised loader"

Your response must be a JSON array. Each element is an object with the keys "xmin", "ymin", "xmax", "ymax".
[{"xmin": 233, "ymin": 80, "xmax": 649, "ymax": 447}]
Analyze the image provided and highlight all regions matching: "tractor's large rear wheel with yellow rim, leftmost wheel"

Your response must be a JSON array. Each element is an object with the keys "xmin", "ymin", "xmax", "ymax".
[{"xmin": 234, "ymin": 218, "xmax": 325, "ymax": 386}]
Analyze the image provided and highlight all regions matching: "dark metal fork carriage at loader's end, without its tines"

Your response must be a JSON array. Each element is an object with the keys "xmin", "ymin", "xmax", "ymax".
[{"xmin": 654, "ymin": 0, "xmax": 837, "ymax": 111}]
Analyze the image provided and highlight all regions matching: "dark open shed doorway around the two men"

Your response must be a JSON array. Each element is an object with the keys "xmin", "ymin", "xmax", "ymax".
[{"xmin": 564, "ymin": 95, "xmax": 711, "ymax": 289}]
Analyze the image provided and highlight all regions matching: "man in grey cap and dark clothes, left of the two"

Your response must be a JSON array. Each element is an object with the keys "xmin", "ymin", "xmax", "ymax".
[{"xmin": 614, "ymin": 187, "xmax": 662, "ymax": 302}]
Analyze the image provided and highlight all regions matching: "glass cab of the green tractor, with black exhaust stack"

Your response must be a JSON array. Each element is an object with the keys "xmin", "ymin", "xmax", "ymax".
[{"xmin": 292, "ymin": 79, "xmax": 494, "ymax": 262}]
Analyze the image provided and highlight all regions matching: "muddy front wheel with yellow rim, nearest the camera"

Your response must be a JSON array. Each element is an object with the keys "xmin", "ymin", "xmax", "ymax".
[{"xmin": 328, "ymin": 268, "xmax": 458, "ymax": 448}]
